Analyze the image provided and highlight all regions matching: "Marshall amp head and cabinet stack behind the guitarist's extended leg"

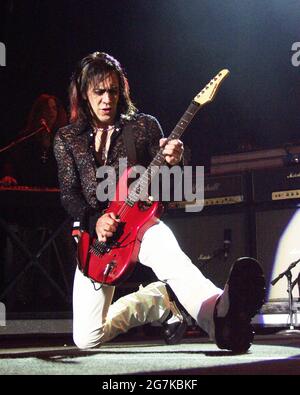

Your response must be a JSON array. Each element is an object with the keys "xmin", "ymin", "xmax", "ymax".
[{"xmin": 163, "ymin": 173, "xmax": 251, "ymax": 287}]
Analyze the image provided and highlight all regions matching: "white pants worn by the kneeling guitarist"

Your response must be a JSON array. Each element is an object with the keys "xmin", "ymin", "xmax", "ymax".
[{"xmin": 73, "ymin": 221, "xmax": 222, "ymax": 348}]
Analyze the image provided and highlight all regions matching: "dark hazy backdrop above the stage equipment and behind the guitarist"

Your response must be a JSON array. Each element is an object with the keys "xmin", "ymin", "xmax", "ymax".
[{"xmin": 0, "ymin": 0, "xmax": 300, "ymax": 164}]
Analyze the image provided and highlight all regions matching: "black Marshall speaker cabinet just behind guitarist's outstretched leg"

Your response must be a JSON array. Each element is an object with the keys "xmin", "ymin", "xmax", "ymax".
[{"xmin": 163, "ymin": 207, "xmax": 249, "ymax": 288}]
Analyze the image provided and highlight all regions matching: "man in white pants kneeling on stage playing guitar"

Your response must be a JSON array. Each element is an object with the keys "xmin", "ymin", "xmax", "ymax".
[{"xmin": 54, "ymin": 52, "xmax": 264, "ymax": 352}]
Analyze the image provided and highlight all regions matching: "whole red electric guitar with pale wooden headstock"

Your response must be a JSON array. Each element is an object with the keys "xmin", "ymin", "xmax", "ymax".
[{"xmin": 78, "ymin": 69, "xmax": 229, "ymax": 285}]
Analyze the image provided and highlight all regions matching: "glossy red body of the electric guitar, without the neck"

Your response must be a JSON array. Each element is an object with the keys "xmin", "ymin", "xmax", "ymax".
[{"xmin": 77, "ymin": 168, "xmax": 163, "ymax": 285}]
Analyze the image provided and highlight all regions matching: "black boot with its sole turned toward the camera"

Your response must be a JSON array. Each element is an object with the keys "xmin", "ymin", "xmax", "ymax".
[{"xmin": 214, "ymin": 257, "xmax": 265, "ymax": 353}]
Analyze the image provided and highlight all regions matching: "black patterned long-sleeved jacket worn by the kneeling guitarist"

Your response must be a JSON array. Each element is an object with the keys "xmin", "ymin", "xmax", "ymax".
[{"xmin": 54, "ymin": 113, "xmax": 163, "ymax": 231}]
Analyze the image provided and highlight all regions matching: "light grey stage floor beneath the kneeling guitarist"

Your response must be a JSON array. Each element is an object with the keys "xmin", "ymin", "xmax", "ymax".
[{"xmin": 0, "ymin": 333, "xmax": 300, "ymax": 379}]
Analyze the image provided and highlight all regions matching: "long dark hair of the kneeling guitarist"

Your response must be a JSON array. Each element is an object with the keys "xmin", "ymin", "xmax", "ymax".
[{"xmin": 69, "ymin": 52, "xmax": 137, "ymax": 122}]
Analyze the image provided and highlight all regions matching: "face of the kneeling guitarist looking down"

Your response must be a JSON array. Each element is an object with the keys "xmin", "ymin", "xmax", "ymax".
[{"xmin": 87, "ymin": 72, "xmax": 120, "ymax": 127}]
